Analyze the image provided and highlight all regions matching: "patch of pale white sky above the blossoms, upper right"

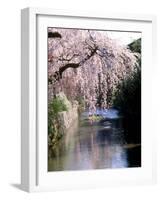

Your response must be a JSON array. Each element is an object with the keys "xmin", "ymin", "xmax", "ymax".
[{"xmin": 106, "ymin": 31, "xmax": 141, "ymax": 45}]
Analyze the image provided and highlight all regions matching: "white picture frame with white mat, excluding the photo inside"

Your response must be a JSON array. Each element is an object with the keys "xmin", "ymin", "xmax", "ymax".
[{"xmin": 21, "ymin": 8, "xmax": 156, "ymax": 192}]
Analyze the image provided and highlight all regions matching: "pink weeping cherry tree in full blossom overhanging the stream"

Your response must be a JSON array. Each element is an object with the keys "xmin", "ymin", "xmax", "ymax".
[{"xmin": 48, "ymin": 28, "xmax": 137, "ymax": 110}]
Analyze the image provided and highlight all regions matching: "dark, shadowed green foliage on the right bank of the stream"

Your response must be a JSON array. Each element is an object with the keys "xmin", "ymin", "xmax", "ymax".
[{"xmin": 113, "ymin": 67, "xmax": 141, "ymax": 143}]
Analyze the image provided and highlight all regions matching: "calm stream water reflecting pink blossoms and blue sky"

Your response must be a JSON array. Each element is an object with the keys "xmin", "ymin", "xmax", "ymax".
[{"xmin": 48, "ymin": 109, "xmax": 141, "ymax": 171}]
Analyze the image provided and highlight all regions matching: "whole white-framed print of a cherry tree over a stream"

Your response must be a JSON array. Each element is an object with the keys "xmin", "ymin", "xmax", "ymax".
[{"xmin": 21, "ymin": 8, "xmax": 156, "ymax": 192}]
